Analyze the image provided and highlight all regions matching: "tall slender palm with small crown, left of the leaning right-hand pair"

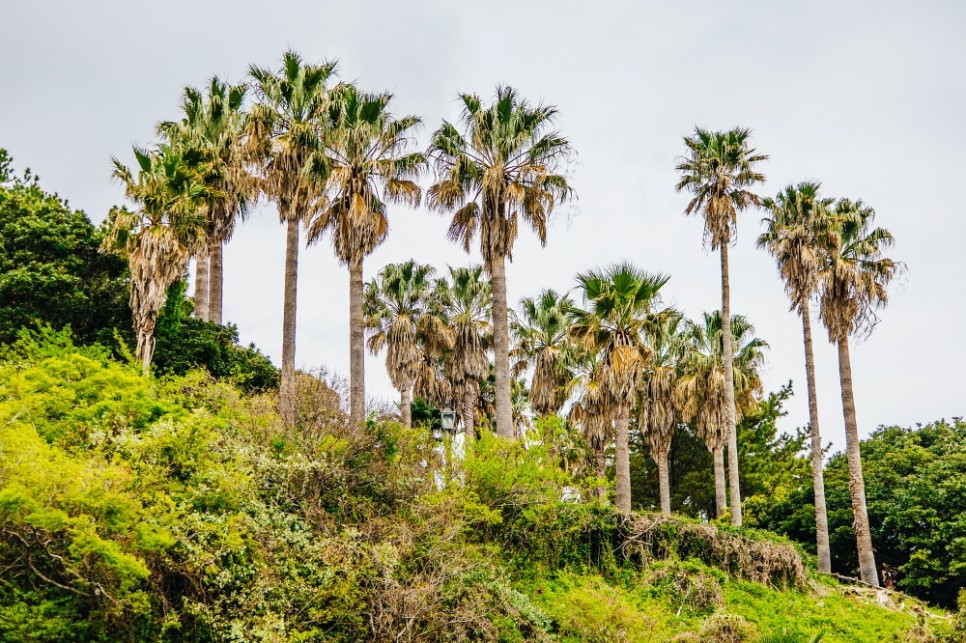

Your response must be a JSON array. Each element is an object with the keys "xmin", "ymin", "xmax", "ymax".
[{"xmin": 675, "ymin": 127, "xmax": 768, "ymax": 526}]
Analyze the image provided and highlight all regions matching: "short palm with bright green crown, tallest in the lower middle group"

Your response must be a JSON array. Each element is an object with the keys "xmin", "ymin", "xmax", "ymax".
[{"xmin": 570, "ymin": 263, "xmax": 669, "ymax": 514}]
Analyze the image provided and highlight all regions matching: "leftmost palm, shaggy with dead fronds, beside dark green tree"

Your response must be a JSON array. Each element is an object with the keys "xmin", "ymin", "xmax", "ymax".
[{"xmin": 103, "ymin": 145, "xmax": 210, "ymax": 375}]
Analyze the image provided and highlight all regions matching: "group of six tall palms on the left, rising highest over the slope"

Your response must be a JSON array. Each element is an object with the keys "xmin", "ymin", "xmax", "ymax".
[{"xmin": 108, "ymin": 51, "xmax": 571, "ymax": 436}]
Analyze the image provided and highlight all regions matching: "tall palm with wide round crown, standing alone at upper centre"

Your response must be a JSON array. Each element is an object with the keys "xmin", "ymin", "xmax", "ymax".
[{"xmin": 427, "ymin": 86, "xmax": 572, "ymax": 437}]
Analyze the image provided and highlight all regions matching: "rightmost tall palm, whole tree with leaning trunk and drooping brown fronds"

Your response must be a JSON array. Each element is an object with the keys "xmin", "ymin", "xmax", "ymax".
[{"xmin": 819, "ymin": 199, "xmax": 902, "ymax": 586}]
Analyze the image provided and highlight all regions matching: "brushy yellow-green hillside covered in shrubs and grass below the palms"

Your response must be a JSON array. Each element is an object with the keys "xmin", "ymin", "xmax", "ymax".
[{"xmin": 0, "ymin": 330, "xmax": 961, "ymax": 642}]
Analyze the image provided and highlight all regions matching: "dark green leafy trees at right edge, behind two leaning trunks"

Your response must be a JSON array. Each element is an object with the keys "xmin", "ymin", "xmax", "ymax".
[{"xmin": 759, "ymin": 418, "xmax": 966, "ymax": 607}]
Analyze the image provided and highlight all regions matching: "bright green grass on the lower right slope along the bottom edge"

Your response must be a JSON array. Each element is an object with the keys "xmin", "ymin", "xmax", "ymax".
[{"xmin": 517, "ymin": 561, "xmax": 948, "ymax": 643}]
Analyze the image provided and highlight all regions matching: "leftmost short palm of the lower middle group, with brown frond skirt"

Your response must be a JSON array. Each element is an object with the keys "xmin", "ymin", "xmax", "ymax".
[{"xmin": 364, "ymin": 260, "xmax": 435, "ymax": 429}]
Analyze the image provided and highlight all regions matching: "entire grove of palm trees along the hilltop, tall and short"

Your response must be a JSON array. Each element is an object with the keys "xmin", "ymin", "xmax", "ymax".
[{"xmin": 105, "ymin": 51, "xmax": 901, "ymax": 583}]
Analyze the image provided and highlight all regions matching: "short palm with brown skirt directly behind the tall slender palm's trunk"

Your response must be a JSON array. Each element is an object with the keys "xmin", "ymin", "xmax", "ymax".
[{"xmin": 675, "ymin": 311, "xmax": 768, "ymax": 518}]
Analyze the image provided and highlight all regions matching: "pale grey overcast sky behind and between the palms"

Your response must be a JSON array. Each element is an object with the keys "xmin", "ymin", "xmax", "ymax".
[{"xmin": 0, "ymin": 0, "xmax": 966, "ymax": 449}]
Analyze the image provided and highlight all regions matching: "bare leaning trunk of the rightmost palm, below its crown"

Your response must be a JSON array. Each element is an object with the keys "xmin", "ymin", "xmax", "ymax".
[{"xmin": 838, "ymin": 335, "xmax": 879, "ymax": 587}]
